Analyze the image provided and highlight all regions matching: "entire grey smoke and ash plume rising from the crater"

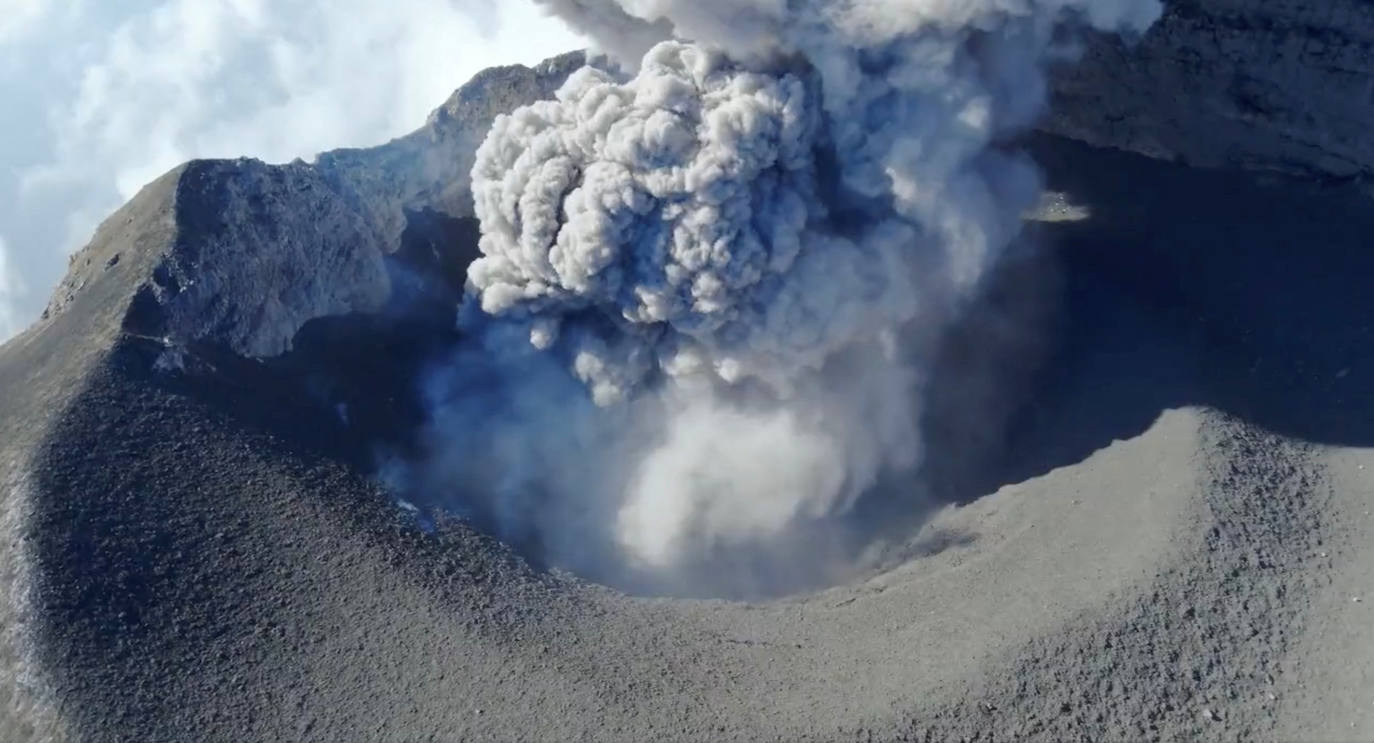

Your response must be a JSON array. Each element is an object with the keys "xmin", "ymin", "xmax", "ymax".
[{"xmin": 403, "ymin": 0, "xmax": 1160, "ymax": 592}]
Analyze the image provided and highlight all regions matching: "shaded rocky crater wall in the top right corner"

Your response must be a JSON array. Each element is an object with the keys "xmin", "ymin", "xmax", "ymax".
[{"xmin": 1044, "ymin": 0, "xmax": 1374, "ymax": 177}]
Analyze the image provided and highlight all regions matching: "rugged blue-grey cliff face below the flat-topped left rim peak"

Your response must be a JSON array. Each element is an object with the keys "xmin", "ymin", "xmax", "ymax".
[{"xmin": 121, "ymin": 161, "xmax": 390, "ymax": 357}]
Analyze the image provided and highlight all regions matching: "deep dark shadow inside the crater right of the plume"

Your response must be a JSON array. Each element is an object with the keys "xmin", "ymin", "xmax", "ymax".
[{"xmin": 927, "ymin": 136, "xmax": 1374, "ymax": 513}]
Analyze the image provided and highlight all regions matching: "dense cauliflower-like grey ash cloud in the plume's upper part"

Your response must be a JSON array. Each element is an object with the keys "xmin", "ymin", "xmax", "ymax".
[{"xmin": 469, "ymin": 43, "xmax": 930, "ymax": 404}]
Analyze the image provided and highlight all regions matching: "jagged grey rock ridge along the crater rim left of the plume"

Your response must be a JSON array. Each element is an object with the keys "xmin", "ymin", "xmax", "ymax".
[{"xmin": 45, "ymin": 52, "xmax": 584, "ymax": 363}]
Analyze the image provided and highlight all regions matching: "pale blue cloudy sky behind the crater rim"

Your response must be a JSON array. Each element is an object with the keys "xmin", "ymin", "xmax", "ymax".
[{"xmin": 0, "ymin": 0, "xmax": 584, "ymax": 339}]
